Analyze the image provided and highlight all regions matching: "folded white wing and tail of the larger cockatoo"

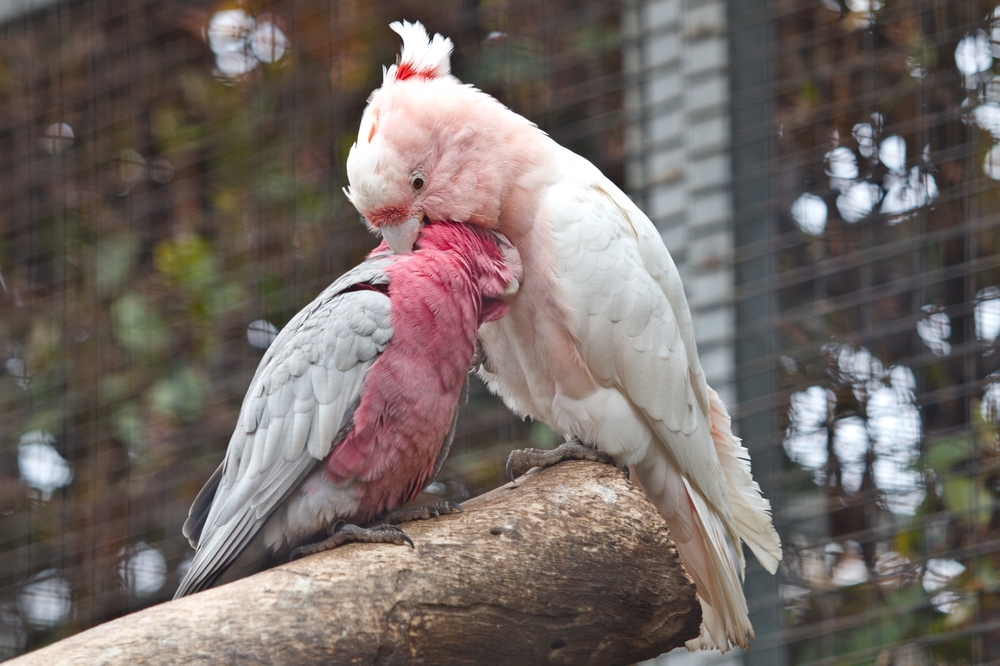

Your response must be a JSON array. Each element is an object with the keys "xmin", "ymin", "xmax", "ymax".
[{"xmin": 542, "ymin": 151, "xmax": 781, "ymax": 650}]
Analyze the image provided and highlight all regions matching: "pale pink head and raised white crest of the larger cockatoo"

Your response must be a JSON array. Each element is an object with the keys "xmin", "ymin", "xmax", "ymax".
[{"xmin": 344, "ymin": 22, "xmax": 531, "ymax": 254}]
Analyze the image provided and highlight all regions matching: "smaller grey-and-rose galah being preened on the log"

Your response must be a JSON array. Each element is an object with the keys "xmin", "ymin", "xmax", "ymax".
[{"xmin": 175, "ymin": 219, "xmax": 521, "ymax": 597}]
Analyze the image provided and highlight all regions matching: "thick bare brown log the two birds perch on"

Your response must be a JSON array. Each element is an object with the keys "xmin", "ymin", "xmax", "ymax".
[{"xmin": 8, "ymin": 462, "xmax": 701, "ymax": 666}]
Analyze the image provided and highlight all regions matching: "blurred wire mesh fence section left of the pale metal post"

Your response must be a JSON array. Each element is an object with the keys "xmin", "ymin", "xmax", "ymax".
[{"xmin": 0, "ymin": 0, "xmax": 623, "ymax": 659}]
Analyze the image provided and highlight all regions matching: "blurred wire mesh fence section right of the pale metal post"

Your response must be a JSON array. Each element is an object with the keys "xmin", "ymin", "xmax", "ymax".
[{"xmin": 731, "ymin": 0, "xmax": 1000, "ymax": 664}]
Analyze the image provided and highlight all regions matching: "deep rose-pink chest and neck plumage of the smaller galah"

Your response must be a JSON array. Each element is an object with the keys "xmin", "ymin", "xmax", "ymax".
[{"xmin": 324, "ymin": 229, "xmax": 508, "ymax": 522}]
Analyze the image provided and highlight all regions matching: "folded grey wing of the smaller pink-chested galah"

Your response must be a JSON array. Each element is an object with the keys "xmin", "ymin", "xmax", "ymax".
[{"xmin": 175, "ymin": 255, "xmax": 397, "ymax": 598}]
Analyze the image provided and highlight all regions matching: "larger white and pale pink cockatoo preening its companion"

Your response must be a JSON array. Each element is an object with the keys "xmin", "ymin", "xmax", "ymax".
[{"xmin": 346, "ymin": 22, "xmax": 781, "ymax": 650}]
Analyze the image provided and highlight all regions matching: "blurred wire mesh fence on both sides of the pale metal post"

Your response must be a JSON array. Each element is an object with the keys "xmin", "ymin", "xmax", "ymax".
[{"xmin": 0, "ymin": 0, "xmax": 1000, "ymax": 665}]
